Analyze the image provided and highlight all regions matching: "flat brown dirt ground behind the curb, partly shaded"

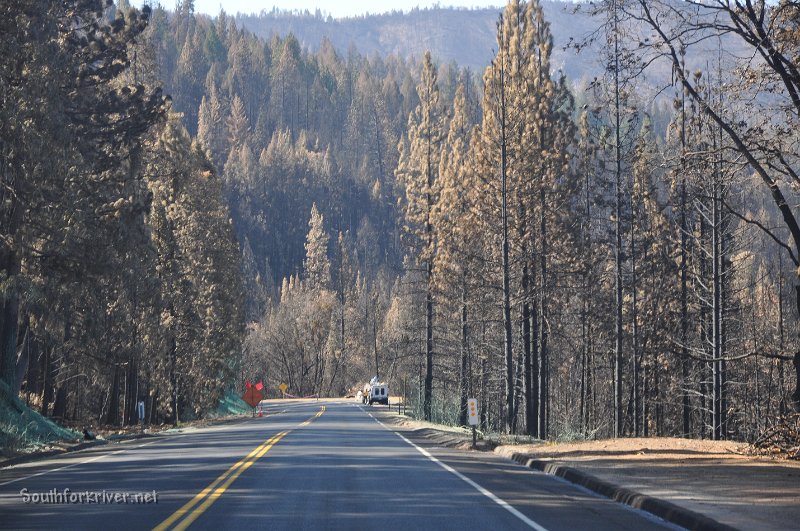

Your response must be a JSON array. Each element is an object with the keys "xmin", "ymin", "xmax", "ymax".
[{"xmin": 495, "ymin": 437, "xmax": 800, "ymax": 529}]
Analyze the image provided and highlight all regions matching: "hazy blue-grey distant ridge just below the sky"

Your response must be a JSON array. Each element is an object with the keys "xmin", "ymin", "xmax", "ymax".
[{"xmin": 236, "ymin": 0, "xmax": 603, "ymax": 81}]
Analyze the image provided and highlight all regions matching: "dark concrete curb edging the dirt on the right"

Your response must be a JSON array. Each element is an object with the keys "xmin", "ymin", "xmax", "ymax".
[{"xmin": 511, "ymin": 453, "xmax": 736, "ymax": 531}]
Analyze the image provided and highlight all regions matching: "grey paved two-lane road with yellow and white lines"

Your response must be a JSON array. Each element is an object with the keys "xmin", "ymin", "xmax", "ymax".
[{"xmin": 0, "ymin": 401, "xmax": 674, "ymax": 531}]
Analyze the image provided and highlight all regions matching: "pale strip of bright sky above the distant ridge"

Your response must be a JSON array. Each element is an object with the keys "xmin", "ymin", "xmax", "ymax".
[{"xmin": 158, "ymin": 0, "xmax": 505, "ymax": 18}]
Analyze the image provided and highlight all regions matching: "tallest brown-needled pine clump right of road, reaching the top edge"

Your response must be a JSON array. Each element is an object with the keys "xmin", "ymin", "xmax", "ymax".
[{"xmin": 468, "ymin": 1, "xmax": 574, "ymax": 436}]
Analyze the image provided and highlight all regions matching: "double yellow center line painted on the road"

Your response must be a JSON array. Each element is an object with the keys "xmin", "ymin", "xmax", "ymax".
[{"xmin": 153, "ymin": 406, "xmax": 325, "ymax": 531}]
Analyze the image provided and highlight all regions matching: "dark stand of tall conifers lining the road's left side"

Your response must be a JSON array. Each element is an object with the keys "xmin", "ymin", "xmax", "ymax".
[{"xmin": 0, "ymin": 0, "xmax": 244, "ymax": 438}]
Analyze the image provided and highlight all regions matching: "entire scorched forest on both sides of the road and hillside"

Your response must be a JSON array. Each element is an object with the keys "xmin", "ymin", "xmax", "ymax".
[{"xmin": 0, "ymin": 0, "xmax": 800, "ymax": 439}]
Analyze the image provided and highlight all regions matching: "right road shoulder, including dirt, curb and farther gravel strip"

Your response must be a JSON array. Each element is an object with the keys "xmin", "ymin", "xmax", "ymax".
[{"xmin": 368, "ymin": 408, "xmax": 800, "ymax": 530}]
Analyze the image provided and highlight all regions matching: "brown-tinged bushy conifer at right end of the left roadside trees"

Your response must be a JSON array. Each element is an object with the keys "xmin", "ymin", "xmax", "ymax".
[{"xmin": 149, "ymin": 118, "xmax": 245, "ymax": 423}]
